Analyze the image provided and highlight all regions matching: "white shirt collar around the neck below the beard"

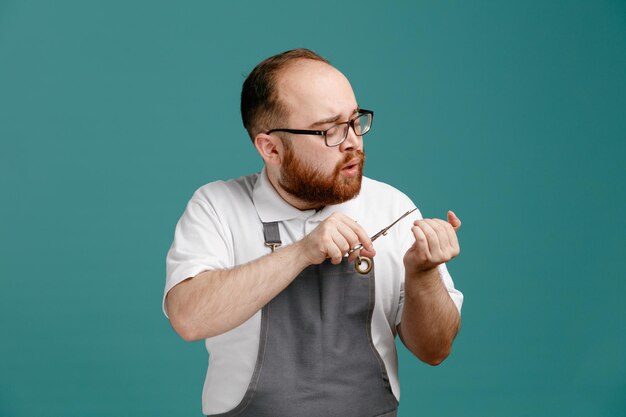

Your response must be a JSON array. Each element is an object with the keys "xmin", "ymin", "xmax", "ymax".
[{"xmin": 252, "ymin": 167, "xmax": 363, "ymax": 223}]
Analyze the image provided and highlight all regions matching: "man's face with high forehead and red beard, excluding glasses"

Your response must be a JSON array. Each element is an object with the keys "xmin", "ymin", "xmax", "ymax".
[{"xmin": 277, "ymin": 60, "xmax": 365, "ymax": 207}]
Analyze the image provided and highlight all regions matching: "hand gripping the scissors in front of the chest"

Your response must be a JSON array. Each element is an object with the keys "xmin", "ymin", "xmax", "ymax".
[{"xmin": 296, "ymin": 213, "xmax": 376, "ymax": 265}]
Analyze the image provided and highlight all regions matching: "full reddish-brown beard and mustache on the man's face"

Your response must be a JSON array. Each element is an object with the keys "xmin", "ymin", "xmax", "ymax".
[{"xmin": 278, "ymin": 145, "xmax": 365, "ymax": 207}]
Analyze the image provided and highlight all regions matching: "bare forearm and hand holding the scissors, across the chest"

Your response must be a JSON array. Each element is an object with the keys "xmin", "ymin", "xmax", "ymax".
[{"xmin": 165, "ymin": 213, "xmax": 376, "ymax": 340}]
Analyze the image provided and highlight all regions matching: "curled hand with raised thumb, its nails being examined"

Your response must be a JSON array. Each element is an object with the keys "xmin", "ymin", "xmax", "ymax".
[{"xmin": 404, "ymin": 211, "xmax": 461, "ymax": 275}]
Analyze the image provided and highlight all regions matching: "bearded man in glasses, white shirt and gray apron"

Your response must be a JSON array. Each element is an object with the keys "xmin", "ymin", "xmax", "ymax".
[{"xmin": 164, "ymin": 49, "xmax": 463, "ymax": 417}]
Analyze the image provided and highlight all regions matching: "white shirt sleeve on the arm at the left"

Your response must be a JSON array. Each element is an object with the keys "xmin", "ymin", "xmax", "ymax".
[{"xmin": 162, "ymin": 197, "xmax": 232, "ymax": 317}]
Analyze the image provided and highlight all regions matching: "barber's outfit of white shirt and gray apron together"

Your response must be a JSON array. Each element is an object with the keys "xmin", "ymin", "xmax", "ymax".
[{"xmin": 164, "ymin": 170, "xmax": 463, "ymax": 417}]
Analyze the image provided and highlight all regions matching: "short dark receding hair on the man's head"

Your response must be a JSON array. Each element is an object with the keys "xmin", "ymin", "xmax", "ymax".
[{"xmin": 241, "ymin": 48, "xmax": 330, "ymax": 142}]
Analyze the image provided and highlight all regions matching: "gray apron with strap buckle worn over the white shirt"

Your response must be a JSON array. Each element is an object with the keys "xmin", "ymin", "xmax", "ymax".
[{"xmin": 207, "ymin": 223, "xmax": 398, "ymax": 417}]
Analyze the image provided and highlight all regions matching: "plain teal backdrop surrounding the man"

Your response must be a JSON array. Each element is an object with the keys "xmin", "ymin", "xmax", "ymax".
[{"xmin": 0, "ymin": 0, "xmax": 626, "ymax": 417}]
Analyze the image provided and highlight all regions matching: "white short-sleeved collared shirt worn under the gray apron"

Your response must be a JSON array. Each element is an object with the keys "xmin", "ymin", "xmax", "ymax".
[{"xmin": 163, "ymin": 169, "xmax": 463, "ymax": 414}]
